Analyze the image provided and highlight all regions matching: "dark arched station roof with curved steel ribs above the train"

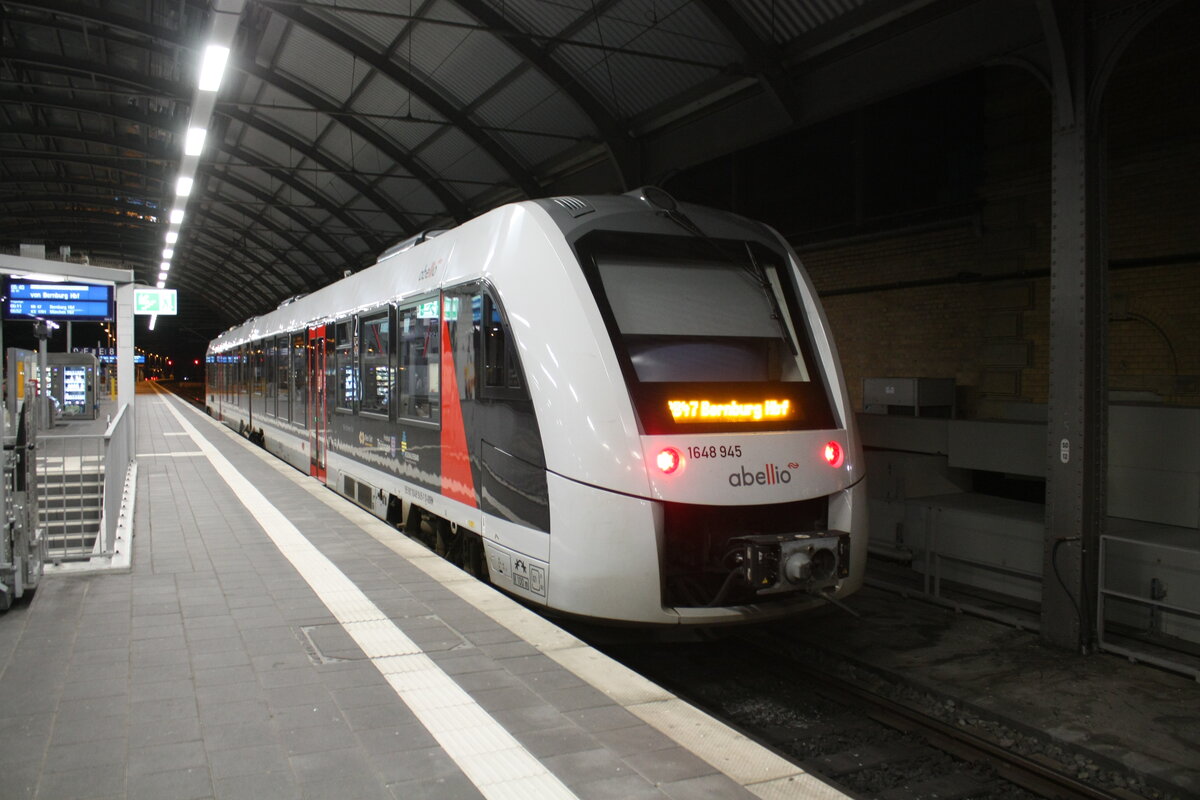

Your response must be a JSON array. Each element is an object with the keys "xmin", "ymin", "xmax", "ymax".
[{"xmin": 0, "ymin": 0, "xmax": 1044, "ymax": 347}]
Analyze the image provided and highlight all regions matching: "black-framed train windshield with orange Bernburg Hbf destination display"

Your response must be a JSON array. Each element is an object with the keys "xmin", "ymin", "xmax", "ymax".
[{"xmin": 582, "ymin": 235, "xmax": 833, "ymax": 433}]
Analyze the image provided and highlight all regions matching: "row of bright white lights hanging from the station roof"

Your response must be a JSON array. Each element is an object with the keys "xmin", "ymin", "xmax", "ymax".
[{"xmin": 162, "ymin": 0, "xmax": 245, "ymax": 289}]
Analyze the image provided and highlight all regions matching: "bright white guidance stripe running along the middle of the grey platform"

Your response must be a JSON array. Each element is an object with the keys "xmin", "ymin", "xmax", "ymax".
[{"xmin": 160, "ymin": 397, "xmax": 576, "ymax": 800}]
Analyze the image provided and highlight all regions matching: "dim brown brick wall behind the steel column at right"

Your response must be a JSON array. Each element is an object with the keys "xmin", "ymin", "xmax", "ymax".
[{"xmin": 802, "ymin": 4, "xmax": 1200, "ymax": 416}]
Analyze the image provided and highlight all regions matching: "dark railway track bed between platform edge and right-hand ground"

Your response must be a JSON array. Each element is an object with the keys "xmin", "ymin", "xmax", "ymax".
[{"xmin": 596, "ymin": 632, "xmax": 1169, "ymax": 800}]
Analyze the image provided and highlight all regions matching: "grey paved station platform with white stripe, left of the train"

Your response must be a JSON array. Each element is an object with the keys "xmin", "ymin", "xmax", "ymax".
[{"xmin": 0, "ymin": 385, "xmax": 842, "ymax": 800}]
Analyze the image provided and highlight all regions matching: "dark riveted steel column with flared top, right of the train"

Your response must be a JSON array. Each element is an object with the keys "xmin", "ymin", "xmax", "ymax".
[{"xmin": 1038, "ymin": 0, "xmax": 1175, "ymax": 652}]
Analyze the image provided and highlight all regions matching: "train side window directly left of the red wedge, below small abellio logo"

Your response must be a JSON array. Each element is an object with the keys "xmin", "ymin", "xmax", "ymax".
[{"xmin": 396, "ymin": 296, "xmax": 442, "ymax": 422}]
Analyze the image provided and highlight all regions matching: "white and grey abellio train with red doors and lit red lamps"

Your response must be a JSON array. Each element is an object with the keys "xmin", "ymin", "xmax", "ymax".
[{"xmin": 206, "ymin": 187, "xmax": 866, "ymax": 625}]
